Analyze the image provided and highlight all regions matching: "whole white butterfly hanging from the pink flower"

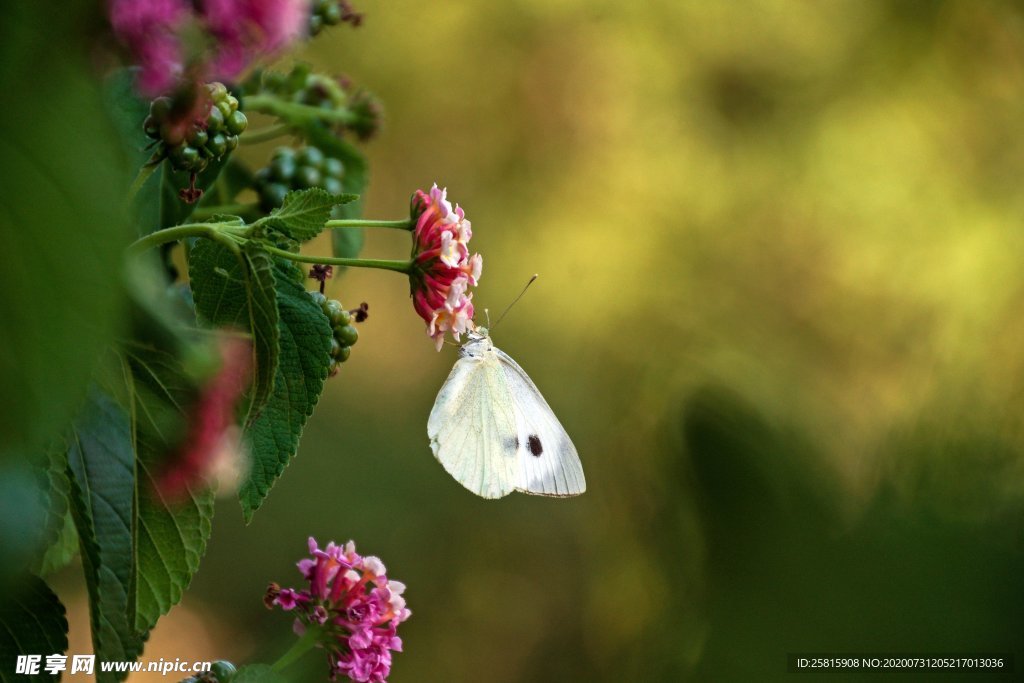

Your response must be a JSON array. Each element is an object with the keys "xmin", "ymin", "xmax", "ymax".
[{"xmin": 427, "ymin": 328, "xmax": 587, "ymax": 498}]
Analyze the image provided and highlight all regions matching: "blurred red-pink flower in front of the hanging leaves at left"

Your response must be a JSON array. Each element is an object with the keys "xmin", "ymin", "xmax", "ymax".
[{"xmin": 157, "ymin": 336, "xmax": 252, "ymax": 498}]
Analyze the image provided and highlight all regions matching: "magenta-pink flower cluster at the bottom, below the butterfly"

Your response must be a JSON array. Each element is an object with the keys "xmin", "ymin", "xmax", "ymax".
[{"xmin": 265, "ymin": 538, "xmax": 412, "ymax": 683}]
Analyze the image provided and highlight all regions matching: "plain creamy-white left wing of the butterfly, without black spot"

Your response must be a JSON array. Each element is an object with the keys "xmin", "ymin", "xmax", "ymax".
[{"xmin": 427, "ymin": 349, "xmax": 518, "ymax": 498}]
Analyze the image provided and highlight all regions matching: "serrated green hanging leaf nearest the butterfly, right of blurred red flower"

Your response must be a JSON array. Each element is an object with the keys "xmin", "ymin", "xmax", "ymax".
[{"xmin": 239, "ymin": 261, "xmax": 332, "ymax": 521}]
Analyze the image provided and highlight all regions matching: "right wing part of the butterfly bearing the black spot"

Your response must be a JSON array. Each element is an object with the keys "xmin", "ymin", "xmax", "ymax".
[{"xmin": 495, "ymin": 348, "xmax": 587, "ymax": 497}]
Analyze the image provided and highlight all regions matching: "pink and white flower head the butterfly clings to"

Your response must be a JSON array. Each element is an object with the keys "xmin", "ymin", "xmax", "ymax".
[{"xmin": 410, "ymin": 183, "xmax": 483, "ymax": 351}]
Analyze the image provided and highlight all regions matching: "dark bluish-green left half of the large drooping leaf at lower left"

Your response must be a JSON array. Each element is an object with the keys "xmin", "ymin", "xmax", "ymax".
[{"xmin": 68, "ymin": 387, "xmax": 144, "ymax": 683}]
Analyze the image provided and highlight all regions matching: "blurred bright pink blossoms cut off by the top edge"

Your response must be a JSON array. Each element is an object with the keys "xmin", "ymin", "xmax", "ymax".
[{"xmin": 110, "ymin": 0, "xmax": 309, "ymax": 95}]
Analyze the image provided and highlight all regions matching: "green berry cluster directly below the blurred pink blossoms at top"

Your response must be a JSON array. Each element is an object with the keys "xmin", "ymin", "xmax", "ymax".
[{"xmin": 142, "ymin": 83, "xmax": 249, "ymax": 173}]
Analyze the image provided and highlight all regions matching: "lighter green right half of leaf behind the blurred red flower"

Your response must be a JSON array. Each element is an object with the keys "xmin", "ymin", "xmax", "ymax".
[{"xmin": 123, "ymin": 344, "xmax": 213, "ymax": 632}]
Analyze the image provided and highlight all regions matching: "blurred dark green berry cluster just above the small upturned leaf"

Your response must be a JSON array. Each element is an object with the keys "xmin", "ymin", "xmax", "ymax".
[{"xmin": 253, "ymin": 146, "xmax": 345, "ymax": 211}]
